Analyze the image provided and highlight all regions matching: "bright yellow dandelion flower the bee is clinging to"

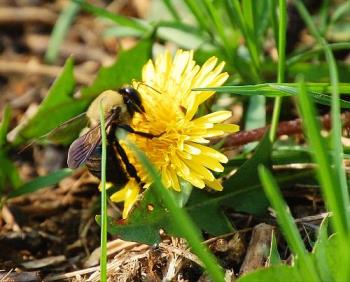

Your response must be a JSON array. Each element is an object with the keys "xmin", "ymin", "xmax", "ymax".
[{"xmin": 112, "ymin": 50, "xmax": 239, "ymax": 218}]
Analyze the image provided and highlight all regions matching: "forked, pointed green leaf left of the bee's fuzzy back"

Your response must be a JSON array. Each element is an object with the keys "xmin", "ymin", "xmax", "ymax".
[{"xmin": 10, "ymin": 58, "xmax": 91, "ymax": 146}]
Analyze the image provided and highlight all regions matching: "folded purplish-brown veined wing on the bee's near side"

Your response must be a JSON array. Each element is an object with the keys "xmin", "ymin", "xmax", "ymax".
[{"xmin": 67, "ymin": 115, "xmax": 114, "ymax": 169}]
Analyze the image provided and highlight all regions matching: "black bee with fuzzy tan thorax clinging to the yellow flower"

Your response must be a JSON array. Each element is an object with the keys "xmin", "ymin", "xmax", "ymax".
[{"xmin": 67, "ymin": 86, "xmax": 159, "ymax": 188}]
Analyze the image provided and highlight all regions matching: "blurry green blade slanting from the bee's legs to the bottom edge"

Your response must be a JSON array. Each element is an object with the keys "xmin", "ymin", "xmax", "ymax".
[{"xmin": 128, "ymin": 143, "xmax": 225, "ymax": 281}]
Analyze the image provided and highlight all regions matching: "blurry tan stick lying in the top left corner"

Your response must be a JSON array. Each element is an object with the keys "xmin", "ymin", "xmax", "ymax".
[{"xmin": 0, "ymin": 7, "xmax": 57, "ymax": 25}]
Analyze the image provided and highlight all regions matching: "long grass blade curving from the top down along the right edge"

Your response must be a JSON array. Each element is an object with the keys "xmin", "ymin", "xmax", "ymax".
[{"xmin": 295, "ymin": 0, "xmax": 350, "ymax": 234}]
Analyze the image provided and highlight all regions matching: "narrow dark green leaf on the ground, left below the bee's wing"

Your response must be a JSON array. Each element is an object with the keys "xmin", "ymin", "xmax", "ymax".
[{"xmin": 8, "ymin": 168, "xmax": 72, "ymax": 198}]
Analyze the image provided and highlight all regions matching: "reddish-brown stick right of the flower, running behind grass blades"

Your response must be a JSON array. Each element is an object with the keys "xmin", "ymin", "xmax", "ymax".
[{"xmin": 224, "ymin": 112, "xmax": 350, "ymax": 147}]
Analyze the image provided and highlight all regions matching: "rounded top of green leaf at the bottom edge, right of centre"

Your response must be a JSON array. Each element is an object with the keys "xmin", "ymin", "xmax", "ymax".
[{"xmin": 237, "ymin": 265, "xmax": 304, "ymax": 282}]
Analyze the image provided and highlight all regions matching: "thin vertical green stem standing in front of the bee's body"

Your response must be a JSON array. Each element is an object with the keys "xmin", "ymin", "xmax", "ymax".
[{"xmin": 100, "ymin": 103, "xmax": 107, "ymax": 282}]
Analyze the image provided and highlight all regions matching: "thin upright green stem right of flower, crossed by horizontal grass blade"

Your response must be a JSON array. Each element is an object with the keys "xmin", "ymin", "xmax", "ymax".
[{"xmin": 270, "ymin": 0, "xmax": 287, "ymax": 142}]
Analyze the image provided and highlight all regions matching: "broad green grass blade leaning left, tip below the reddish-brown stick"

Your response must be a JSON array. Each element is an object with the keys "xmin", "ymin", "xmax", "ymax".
[{"xmin": 258, "ymin": 165, "xmax": 320, "ymax": 281}]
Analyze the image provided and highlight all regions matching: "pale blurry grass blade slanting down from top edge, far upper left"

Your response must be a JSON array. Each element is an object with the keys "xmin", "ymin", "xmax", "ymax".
[{"xmin": 45, "ymin": 2, "xmax": 80, "ymax": 63}]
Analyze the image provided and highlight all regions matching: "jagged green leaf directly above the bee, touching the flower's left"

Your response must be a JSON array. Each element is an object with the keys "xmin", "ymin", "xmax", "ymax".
[{"xmin": 82, "ymin": 40, "xmax": 152, "ymax": 96}]
